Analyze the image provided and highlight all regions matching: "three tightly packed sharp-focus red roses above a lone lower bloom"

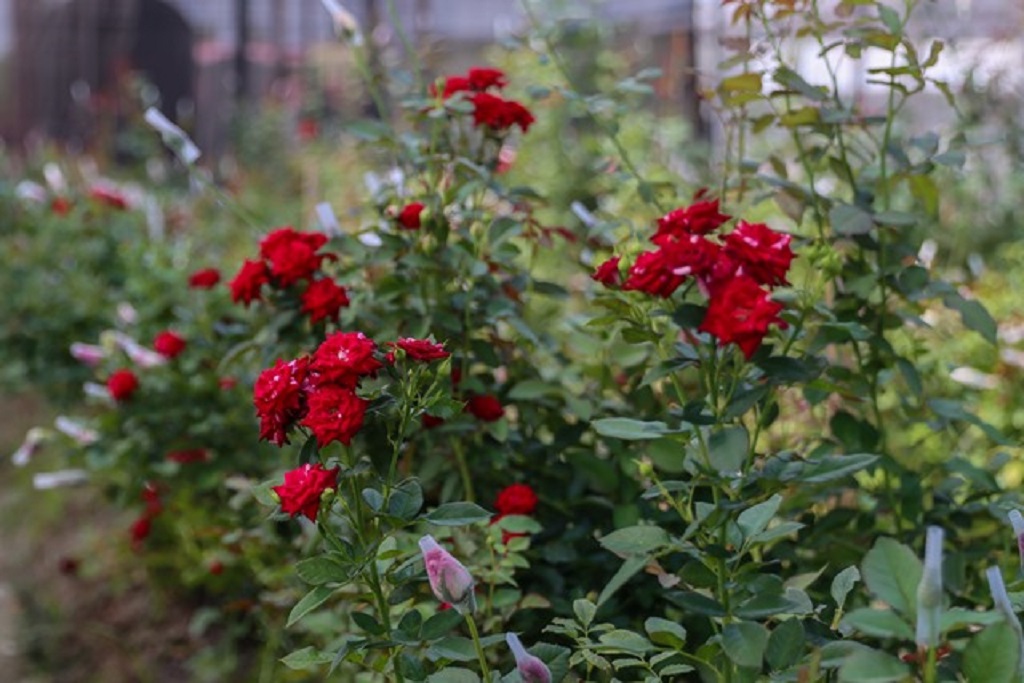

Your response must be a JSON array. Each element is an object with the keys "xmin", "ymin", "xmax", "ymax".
[{"xmin": 253, "ymin": 332, "xmax": 381, "ymax": 446}]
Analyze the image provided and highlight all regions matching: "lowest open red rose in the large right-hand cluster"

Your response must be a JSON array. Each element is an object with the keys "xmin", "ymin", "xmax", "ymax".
[{"xmin": 698, "ymin": 275, "xmax": 786, "ymax": 359}]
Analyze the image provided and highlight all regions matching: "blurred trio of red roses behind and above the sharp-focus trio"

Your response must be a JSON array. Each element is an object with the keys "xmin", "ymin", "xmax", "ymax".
[{"xmin": 226, "ymin": 227, "xmax": 349, "ymax": 323}]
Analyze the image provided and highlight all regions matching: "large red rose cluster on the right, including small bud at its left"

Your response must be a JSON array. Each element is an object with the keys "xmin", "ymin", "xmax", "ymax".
[{"xmin": 592, "ymin": 200, "xmax": 794, "ymax": 358}]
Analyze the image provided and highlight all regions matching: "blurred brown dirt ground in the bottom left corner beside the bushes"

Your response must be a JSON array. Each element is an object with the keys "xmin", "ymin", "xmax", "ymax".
[{"xmin": 0, "ymin": 396, "xmax": 197, "ymax": 683}]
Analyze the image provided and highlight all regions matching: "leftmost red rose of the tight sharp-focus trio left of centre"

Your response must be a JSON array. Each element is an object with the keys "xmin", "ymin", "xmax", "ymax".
[{"xmin": 253, "ymin": 357, "xmax": 309, "ymax": 445}]
